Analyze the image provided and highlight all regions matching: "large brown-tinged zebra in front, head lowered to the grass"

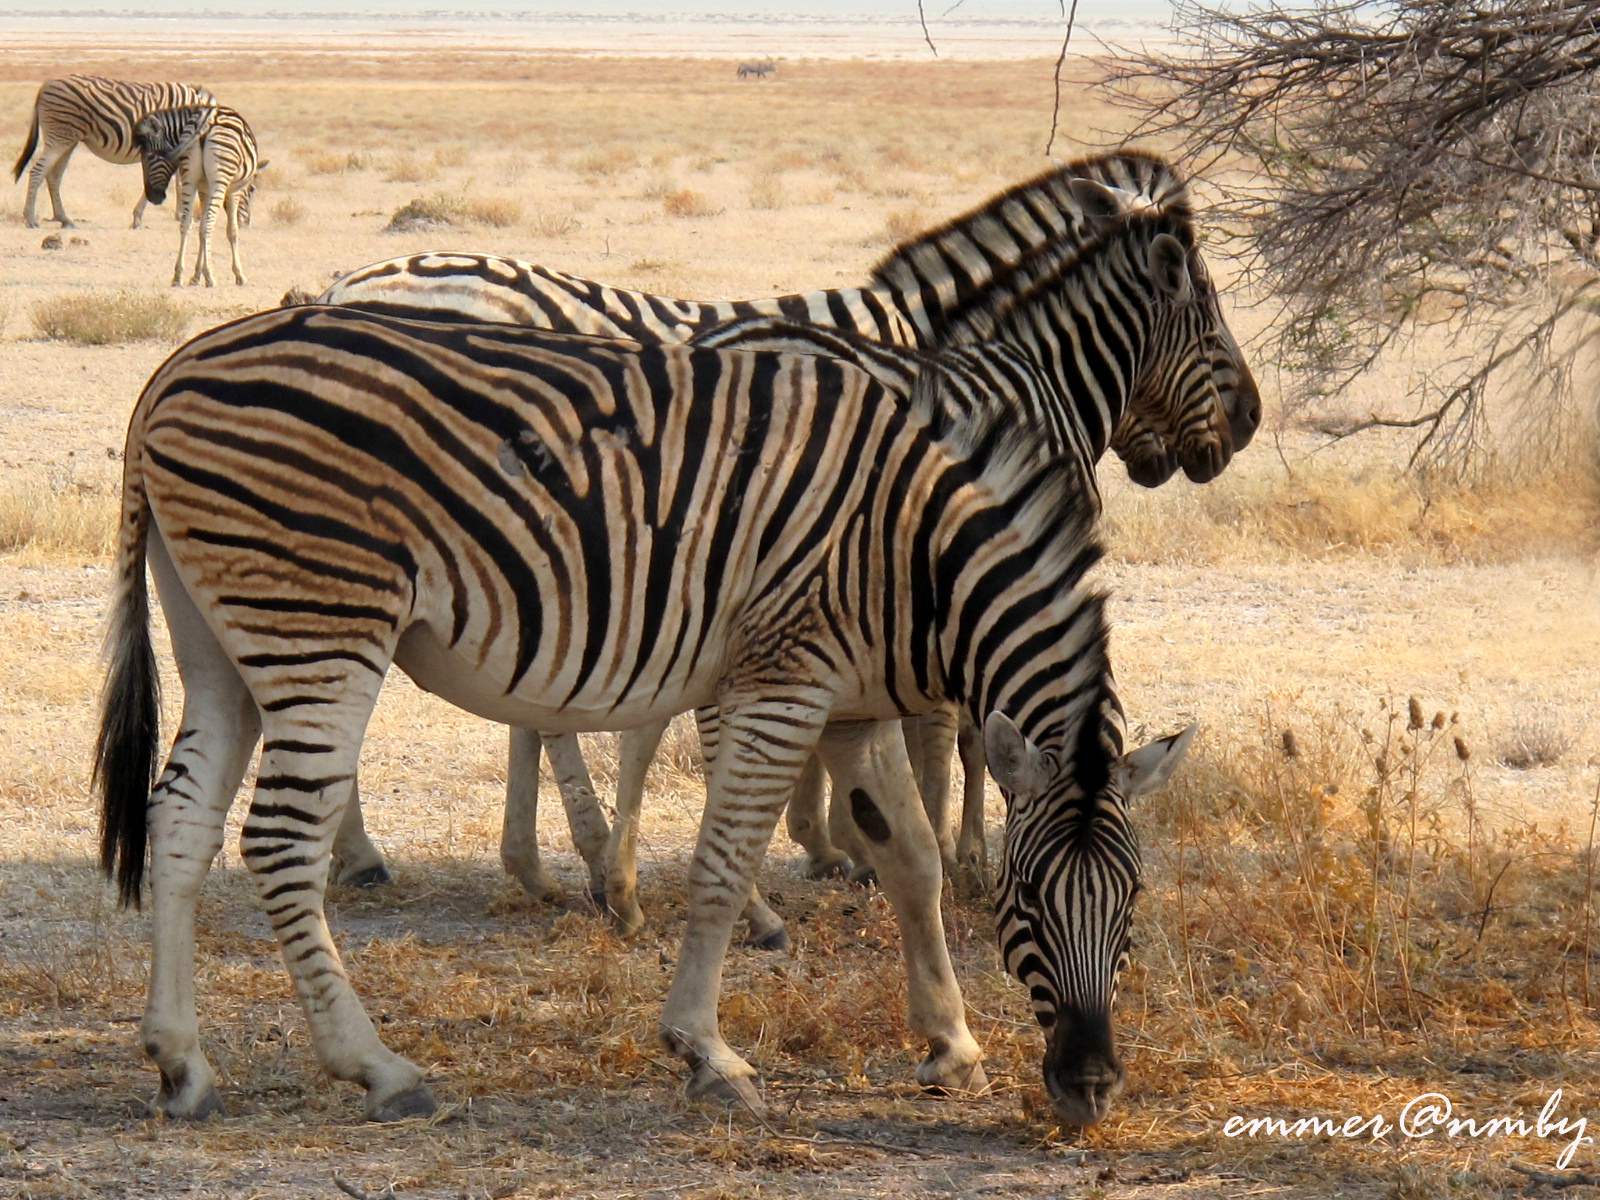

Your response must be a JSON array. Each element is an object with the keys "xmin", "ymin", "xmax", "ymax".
[{"xmin": 96, "ymin": 300, "xmax": 1189, "ymax": 1123}]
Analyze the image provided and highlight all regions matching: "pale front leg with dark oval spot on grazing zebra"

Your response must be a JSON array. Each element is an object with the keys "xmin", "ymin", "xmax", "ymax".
[{"xmin": 818, "ymin": 722, "xmax": 989, "ymax": 1091}]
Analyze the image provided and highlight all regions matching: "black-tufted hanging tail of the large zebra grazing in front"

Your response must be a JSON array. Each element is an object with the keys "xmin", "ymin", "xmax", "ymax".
[{"xmin": 94, "ymin": 457, "xmax": 162, "ymax": 909}]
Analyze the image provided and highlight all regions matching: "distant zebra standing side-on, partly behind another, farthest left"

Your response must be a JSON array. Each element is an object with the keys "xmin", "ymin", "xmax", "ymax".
[{"xmin": 11, "ymin": 75, "xmax": 216, "ymax": 229}]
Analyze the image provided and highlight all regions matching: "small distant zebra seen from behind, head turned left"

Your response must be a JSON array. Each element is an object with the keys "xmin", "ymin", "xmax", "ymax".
[{"xmin": 133, "ymin": 106, "xmax": 266, "ymax": 288}]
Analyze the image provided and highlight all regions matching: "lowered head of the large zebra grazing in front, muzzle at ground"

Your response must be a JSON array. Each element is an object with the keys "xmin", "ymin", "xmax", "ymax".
[{"xmin": 984, "ymin": 699, "xmax": 1195, "ymax": 1125}]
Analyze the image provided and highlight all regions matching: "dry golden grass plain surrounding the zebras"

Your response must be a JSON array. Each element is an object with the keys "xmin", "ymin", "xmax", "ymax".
[{"xmin": 0, "ymin": 38, "xmax": 1600, "ymax": 1200}]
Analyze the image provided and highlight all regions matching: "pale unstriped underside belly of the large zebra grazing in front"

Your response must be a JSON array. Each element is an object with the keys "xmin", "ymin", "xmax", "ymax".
[{"xmin": 394, "ymin": 624, "xmax": 717, "ymax": 733}]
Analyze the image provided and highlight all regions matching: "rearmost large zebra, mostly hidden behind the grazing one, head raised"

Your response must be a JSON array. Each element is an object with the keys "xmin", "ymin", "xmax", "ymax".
[{"xmin": 315, "ymin": 152, "xmax": 1261, "ymax": 915}]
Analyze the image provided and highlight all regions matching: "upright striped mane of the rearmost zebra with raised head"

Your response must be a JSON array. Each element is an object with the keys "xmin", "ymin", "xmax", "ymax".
[{"xmin": 869, "ymin": 150, "xmax": 1192, "ymax": 310}]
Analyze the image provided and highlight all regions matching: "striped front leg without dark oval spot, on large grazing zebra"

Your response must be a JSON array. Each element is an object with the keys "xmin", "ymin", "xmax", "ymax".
[{"xmin": 661, "ymin": 685, "xmax": 826, "ymax": 1114}]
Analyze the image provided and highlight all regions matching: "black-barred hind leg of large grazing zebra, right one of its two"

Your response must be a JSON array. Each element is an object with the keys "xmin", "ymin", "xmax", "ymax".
[{"xmin": 238, "ymin": 710, "xmax": 435, "ymax": 1122}]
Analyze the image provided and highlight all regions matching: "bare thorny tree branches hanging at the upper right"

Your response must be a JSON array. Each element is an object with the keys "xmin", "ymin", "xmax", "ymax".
[{"xmin": 1110, "ymin": 0, "xmax": 1600, "ymax": 470}]
